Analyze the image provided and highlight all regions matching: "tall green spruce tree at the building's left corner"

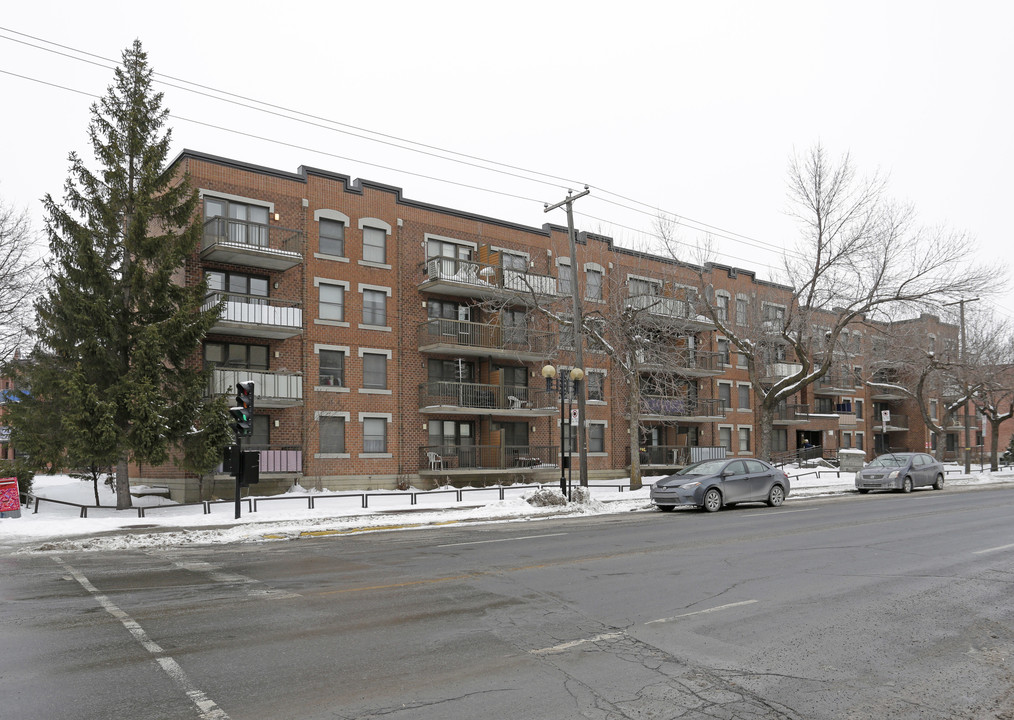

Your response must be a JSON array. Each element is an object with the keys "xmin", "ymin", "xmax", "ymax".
[{"xmin": 11, "ymin": 41, "xmax": 228, "ymax": 508}]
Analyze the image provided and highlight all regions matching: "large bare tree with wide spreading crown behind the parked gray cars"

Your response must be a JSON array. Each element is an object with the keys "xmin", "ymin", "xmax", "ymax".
[{"xmin": 657, "ymin": 144, "xmax": 997, "ymax": 457}]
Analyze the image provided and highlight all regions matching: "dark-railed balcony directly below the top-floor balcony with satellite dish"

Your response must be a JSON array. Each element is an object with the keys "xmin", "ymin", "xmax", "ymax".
[{"xmin": 419, "ymin": 317, "xmax": 557, "ymax": 362}]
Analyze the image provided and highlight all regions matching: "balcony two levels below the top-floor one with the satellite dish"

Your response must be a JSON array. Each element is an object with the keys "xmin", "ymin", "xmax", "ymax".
[{"xmin": 419, "ymin": 380, "xmax": 559, "ymax": 418}]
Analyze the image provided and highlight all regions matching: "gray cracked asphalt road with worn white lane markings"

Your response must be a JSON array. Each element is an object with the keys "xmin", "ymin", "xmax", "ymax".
[{"xmin": 0, "ymin": 487, "xmax": 1014, "ymax": 720}]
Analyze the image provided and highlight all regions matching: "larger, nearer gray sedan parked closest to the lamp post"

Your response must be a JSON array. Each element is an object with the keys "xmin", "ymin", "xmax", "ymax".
[{"xmin": 651, "ymin": 457, "xmax": 789, "ymax": 512}]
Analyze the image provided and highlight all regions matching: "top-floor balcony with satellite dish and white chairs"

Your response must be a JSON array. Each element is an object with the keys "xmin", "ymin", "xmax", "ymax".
[{"xmin": 419, "ymin": 258, "xmax": 558, "ymax": 297}]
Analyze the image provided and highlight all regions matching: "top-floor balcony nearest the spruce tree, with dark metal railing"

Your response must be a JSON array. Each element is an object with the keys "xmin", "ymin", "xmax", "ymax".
[{"xmin": 201, "ymin": 217, "xmax": 303, "ymax": 272}]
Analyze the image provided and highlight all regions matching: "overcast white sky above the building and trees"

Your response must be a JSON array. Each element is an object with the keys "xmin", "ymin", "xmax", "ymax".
[{"xmin": 0, "ymin": 0, "xmax": 1014, "ymax": 324}]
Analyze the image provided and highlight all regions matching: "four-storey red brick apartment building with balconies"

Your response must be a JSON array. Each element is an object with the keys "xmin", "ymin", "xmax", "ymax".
[{"xmin": 126, "ymin": 151, "xmax": 981, "ymax": 500}]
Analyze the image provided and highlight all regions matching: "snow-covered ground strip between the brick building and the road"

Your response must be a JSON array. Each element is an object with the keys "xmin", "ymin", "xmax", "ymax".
[{"xmin": 0, "ymin": 465, "xmax": 1014, "ymax": 553}]
